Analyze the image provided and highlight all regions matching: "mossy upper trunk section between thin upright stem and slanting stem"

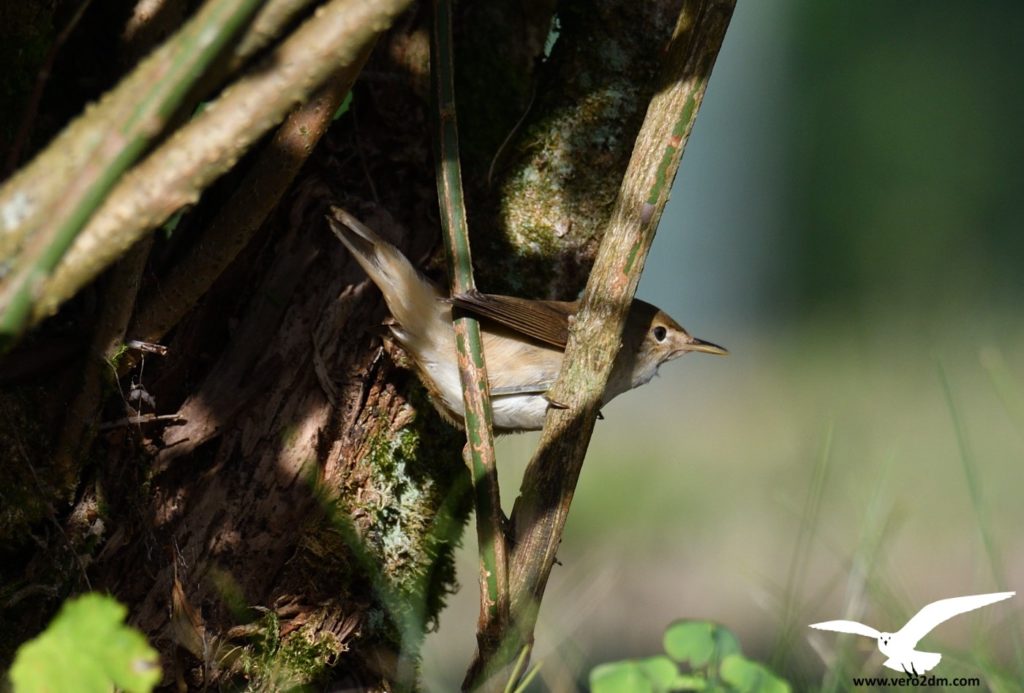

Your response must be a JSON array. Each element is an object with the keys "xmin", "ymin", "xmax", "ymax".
[{"xmin": 474, "ymin": 0, "xmax": 680, "ymax": 299}]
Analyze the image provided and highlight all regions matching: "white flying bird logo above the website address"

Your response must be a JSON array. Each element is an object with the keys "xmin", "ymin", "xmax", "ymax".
[{"xmin": 811, "ymin": 592, "xmax": 1017, "ymax": 675}]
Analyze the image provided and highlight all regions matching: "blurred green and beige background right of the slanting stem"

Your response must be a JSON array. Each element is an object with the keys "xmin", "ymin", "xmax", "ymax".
[{"xmin": 423, "ymin": 0, "xmax": 1024, "ymax": 690}]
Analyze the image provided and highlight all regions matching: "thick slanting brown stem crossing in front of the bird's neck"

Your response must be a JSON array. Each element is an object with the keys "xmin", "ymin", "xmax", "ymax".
[{"xmin": 470, "ymin": 0, "xmax": 735, "ymax": 682}]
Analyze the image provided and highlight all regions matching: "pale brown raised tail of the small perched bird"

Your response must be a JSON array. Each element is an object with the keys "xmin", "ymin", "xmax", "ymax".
[{"xmin": 328, "ymin": 207, "xmax": 441, "ymax": 341}]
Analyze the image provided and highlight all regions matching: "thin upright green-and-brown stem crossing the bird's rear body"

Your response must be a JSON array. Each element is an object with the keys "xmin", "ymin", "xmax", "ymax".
[{"xmin": 430, "ymin": 0, "xmax": 509, "ymax": 675}]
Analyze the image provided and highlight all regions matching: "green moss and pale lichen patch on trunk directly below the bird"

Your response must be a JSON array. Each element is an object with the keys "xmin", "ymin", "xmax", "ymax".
[{"xmin": 288, "ymin": 388, "xmax": 471, "ymax": 670}]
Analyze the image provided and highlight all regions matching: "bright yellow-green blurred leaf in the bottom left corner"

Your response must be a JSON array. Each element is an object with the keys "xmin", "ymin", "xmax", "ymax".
[{"xmin": 10, "ymin": 594, "xmax": 161, "ymax": 693}]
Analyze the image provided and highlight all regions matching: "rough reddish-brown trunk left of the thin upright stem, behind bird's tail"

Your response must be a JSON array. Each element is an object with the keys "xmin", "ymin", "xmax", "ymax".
[{"xmin": 0, "ymin": 9, "xmax": 470, "ymax": 690}]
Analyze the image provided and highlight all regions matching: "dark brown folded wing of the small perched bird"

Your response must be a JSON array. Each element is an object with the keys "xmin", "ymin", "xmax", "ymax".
[{"xmin": 452, "ymin": 292, "xmax": 575, "ymax": 351}]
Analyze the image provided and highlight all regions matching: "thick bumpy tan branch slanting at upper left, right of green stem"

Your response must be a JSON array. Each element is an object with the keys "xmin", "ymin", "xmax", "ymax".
[{"xmin": 0, "ymin": 0, "xmax": 410, "ymax": 345}]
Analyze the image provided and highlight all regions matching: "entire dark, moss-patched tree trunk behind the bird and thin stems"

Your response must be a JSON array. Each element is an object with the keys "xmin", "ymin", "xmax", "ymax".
[{"xmin": 0, "ymin": 0, "xmax": 680, "ymax": 690}]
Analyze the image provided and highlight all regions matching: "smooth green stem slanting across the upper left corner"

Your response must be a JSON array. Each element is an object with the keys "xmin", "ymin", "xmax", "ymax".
[{"xmin": 0, "ymin": 0, "xmax": 260, "ymax": 349}]
